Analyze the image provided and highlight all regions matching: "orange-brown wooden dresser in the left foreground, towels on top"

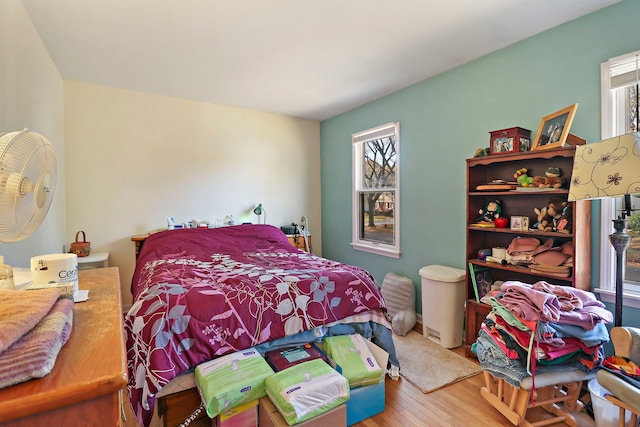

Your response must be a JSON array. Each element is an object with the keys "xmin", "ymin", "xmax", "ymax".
[{"xmin": 0, "ymin": 267, "xmax": 127, "ymax": 427}]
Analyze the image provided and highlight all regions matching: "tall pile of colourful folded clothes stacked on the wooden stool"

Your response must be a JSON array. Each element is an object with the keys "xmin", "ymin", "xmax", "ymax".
[{"xmin": 472, "ymin": 281, "xmax": 613, "ymax": 387}]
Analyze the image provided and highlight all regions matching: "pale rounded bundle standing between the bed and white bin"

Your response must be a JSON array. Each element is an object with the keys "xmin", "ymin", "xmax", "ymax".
[{"xmin": 381, "ymin": 273, "xmax": 416, "ymax": 336}]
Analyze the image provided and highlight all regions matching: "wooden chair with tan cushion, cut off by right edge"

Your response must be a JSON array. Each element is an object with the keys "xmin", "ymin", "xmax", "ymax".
[{"xmin": 597, "ymin": 326, "xmax": 640, "ymax": 427}]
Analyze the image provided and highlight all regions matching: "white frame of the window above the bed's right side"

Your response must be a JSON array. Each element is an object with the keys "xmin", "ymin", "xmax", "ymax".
[{"xmin": 351, "ymin": 122, "xmax": 401, "ymax": 258}]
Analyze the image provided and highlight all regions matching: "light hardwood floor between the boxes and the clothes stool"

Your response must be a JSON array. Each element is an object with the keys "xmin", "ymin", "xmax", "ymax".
[{"xmin": 124, "ymin": 347, "xmax": 595, "ymax": 427}]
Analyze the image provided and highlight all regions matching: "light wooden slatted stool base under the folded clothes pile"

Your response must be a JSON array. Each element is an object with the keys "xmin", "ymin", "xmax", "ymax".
[{"xmin": 480, "ymin": 371, "xmax": 595, "ymax": 427}]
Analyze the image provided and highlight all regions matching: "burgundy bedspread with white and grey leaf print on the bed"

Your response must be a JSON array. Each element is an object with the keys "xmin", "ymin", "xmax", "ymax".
[{"xmin": 125, "ymin": 224, "xmax": 399, "ymax": 426}]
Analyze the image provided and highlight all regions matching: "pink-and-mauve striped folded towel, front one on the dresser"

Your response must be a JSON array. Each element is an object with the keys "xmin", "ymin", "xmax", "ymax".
[{"xmin": 0, "ymin": 291, "xmax": 73, "ymax": 388}]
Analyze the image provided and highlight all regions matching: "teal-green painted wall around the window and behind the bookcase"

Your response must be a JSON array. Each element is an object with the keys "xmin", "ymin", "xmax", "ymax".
[{"xmin": 320, "ymin": 0, "xmax": 640, "ymax": 324}]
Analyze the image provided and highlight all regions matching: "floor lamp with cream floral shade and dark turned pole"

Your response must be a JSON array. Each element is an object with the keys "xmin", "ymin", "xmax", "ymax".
[{"xmin": 568, "ymin": 132, "xmax": 640, "ymax": 326}]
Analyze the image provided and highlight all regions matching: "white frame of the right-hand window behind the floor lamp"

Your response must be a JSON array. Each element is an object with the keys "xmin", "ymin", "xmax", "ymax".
[{"xmin": 594, "ymin": 51, "xmax": 640, "ymax": 308}]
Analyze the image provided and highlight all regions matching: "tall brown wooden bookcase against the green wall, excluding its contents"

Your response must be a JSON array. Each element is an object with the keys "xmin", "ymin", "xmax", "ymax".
[{"xmin": 465, "ymin": 146, "xmax": 591, "ymax": 356}]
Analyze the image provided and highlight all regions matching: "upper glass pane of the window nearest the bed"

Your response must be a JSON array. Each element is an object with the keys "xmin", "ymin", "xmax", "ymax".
[{"xmin": 363, "ymin": 136, "xmax": 396, "ymax": 189}]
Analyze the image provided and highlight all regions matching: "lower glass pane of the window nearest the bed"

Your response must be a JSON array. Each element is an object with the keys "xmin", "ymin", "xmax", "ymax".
[{"xmin": 360, "ymin": 191, "xmax": 395, "ymax": 245}]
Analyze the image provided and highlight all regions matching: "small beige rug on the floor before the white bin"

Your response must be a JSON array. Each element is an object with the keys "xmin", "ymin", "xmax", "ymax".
[{"xmin": 393, "ymin": 331, "xmax": 482, "ymax": 393}]
